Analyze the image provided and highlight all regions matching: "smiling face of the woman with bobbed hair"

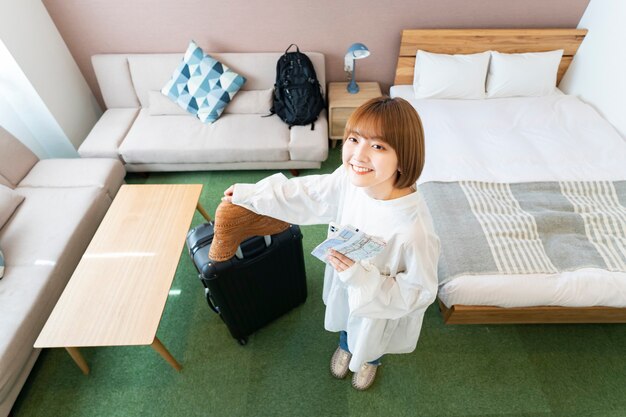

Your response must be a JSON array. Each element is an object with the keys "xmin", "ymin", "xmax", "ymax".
[{"xmin": 341, "ymin": 133, "xmax": 398, "ymax": 200}]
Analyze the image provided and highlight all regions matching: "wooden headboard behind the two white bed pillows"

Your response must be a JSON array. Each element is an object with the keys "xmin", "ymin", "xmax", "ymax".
[{"xmin": 394, "ymin": 29, "xmax": 587, "ymax": 85}]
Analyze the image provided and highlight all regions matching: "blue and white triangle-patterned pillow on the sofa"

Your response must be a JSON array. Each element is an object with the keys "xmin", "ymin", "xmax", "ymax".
[{"xmin": 161, "ymin": 41, "xmax": 246, "ymax": 123}]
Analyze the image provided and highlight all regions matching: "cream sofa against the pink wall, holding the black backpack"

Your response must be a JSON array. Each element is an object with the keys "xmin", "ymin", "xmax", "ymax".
[{"xmin": 78, "ymin": 52, "xmax": 328, "ymax": 172}]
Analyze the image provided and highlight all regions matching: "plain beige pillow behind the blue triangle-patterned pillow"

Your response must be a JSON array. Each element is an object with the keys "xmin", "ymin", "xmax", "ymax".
[{"xmin": 149, "ymin": 88, "xmax": 274, "ymax": 116}]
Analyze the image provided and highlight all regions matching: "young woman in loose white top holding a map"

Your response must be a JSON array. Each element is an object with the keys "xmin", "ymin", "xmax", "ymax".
[{"xmin": 224, "ymin": 97, "xmax": 439, "ymax": 390}]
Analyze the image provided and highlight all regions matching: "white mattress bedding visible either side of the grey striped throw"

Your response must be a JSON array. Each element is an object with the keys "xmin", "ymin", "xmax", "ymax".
[{"xmin": 390, "ymin": 85, "xmax": 626, "ymax": 307}]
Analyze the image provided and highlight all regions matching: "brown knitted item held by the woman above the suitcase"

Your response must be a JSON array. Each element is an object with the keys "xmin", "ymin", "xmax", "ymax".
[{"xmin": 209, "ymin": 201, "xmax": 289, "ymax": 262}]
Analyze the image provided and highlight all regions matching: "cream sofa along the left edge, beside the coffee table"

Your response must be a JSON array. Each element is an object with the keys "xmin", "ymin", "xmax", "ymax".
[{"xmin": 0, "ymin": 127, "xmax": 125, "ymax": 416}]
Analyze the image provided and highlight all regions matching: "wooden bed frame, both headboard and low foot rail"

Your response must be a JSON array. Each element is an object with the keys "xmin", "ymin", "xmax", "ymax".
[{"xmin": 394, "ymin": 29, "xmax": 626, "ymax": 324}]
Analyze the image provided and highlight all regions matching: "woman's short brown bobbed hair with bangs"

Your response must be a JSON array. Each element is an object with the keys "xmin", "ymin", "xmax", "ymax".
[{"xmin": 343, "ymin": 96, "xmax": 424, "ymax": 188}]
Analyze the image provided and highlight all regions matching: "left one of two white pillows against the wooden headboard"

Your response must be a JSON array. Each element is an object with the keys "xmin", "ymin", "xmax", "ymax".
[{"xmin": 413, "ymin": 51, "xmax": 490, "ymax": 99}]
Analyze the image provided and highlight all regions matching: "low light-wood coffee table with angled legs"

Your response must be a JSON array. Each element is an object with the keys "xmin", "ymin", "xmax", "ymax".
[{"xmin": 34, "ymin": 184, "xmax": 209, "ymax": 374}]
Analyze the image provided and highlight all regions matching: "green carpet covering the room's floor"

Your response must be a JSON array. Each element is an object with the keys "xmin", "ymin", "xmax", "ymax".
[{"xmin": 13, "ymin": 149, "xmax": 626, "ymax": 417}]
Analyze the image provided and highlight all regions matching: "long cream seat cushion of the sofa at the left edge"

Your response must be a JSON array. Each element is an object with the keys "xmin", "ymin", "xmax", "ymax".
[{"xmin": 0, "ymin": 187, "xmax": 110, "ymax": 403}]
